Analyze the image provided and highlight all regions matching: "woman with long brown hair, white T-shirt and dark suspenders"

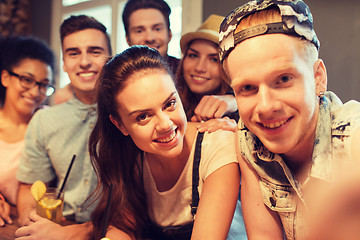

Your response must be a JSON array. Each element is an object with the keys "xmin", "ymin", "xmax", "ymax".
[{"xmin": 89, "ymin": 46, "xmax": 239, "ymax": 240}]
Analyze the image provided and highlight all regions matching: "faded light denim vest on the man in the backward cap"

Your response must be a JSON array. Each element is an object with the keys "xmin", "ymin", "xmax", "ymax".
[{"xmin": 238, "ymin": 92, "xmax": 360, "ymax": 240}]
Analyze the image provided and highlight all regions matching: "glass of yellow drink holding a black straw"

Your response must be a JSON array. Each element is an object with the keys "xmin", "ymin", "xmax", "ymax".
[{"xmin": 36, "ymin": 188, "xmax": 64, "ymax": 224}]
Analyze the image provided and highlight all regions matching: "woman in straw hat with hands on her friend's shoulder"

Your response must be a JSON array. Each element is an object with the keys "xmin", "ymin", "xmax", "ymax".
[{"xmin": 176, "ymin": 14, "xmax": 238, "ymax": 131}]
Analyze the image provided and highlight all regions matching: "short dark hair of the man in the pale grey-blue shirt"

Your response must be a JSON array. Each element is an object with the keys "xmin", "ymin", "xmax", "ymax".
[{"xmin": 60, "ymin": 15, "xmax": 112, "ymax": 55}]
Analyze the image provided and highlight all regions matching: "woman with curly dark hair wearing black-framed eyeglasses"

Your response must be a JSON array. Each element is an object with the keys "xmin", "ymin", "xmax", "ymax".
[{"xmin": 0, "ymin": 37, "xmax": 55, "ymax": 226}]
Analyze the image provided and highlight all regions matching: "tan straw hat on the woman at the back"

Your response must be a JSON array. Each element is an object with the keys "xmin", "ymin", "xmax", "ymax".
[{"xmin": 180, "ymin": 14, "xmax": 224, "ymax": 54}]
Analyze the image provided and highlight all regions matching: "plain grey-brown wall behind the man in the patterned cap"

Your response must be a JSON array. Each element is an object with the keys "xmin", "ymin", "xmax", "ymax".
[{"xmin": 203, "ymin": 0, "xmax": 360, "ymax": 102}]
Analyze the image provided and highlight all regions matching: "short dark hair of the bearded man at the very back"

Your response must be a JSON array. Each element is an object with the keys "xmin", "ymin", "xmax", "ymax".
[{"xmin": 122, "ymin": 0, "xmax": 171, "ymax": 35}]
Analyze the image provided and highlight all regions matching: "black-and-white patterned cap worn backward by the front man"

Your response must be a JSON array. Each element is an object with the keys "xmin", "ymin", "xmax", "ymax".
[{"xmin": 219, "ymin": 0, "xmax": 320, "ymax": 63}]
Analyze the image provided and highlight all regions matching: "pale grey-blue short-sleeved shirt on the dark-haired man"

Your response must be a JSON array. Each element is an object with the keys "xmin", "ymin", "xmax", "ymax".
[{"xmin": 17, "ymin": 97, "xmax": 97, "ymax": 222}]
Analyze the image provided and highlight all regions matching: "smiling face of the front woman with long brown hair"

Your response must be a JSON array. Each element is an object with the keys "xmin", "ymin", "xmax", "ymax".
[{"xmin": 113, "ymin": 70, "xmax": 187, "ymax": 158}]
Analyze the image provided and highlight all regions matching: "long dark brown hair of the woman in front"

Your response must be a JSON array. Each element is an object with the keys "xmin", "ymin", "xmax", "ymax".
[{"xmin": 89, "ymin": 46, "xmax": 172, "ymax": 239}]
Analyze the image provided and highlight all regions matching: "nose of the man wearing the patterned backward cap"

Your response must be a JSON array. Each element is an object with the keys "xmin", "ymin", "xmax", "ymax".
[{"xmin": 256, "ymin": 87, "xmax": 281, "ymax": 116}]
